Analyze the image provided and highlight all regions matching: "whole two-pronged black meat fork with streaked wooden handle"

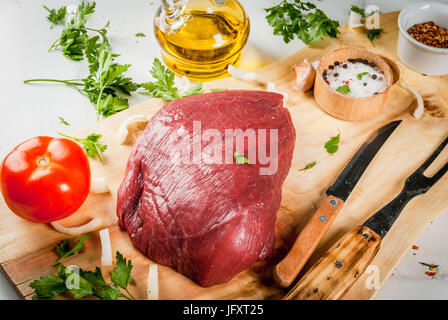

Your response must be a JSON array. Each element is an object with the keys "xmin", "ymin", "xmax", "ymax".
[{"xmin": 284, "ymin": 137, "xmax": 448, "ymax": 300}]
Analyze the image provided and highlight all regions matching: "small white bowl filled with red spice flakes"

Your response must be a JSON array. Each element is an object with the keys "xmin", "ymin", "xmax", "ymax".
[{"xmin": 397, "ymin": 2, "xmax": 448, "ymax": 76}]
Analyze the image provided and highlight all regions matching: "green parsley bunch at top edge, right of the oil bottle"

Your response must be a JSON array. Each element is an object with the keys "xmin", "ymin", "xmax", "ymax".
[{"xmin": 264, "ymin": 0, "xmax": 339, "ymax": 44}]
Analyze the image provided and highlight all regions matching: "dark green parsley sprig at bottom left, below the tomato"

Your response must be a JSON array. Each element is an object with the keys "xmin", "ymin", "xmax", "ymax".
[{"xmin": 30, "ymin": 251, "xmax": 135, "ymax": 300}]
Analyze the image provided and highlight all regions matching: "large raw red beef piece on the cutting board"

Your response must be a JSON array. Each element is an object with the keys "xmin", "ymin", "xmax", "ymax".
[{"xmin": 117, "ymin": 91, "xmax": 295, "ymax": 287}]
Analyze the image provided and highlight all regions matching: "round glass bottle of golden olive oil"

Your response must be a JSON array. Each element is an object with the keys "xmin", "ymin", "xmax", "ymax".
[{"xmin": 154, "ymin": 0, "xmax": 250, "ymax": 81}]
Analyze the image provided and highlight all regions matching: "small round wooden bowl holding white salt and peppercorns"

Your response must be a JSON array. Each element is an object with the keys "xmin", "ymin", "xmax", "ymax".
[{"xmin": 314, "ymin": 47, "xmax": 394, "ymax": 121}]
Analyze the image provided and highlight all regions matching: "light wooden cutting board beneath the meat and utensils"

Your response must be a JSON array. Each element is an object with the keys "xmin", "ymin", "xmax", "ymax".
[{"xmin": 0, "ymin": 12, "xmax": 448, "ymax": 299}]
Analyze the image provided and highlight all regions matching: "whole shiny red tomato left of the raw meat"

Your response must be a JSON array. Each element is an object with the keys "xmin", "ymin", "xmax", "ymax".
[{"xmin": 0, "ymin": 137, "xmax": 90, "ymax": 223}]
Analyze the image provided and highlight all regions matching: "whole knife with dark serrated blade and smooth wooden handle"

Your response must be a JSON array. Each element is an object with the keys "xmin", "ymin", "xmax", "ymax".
[{"xmin": 274, "ymin": 120, "xmax": 401, "ymax": 287}]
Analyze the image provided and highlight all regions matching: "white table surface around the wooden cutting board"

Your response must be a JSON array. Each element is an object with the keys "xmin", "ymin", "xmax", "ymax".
[{"xmin": 0, "ymin": 0, "xmax": 448, "ymax": 299}]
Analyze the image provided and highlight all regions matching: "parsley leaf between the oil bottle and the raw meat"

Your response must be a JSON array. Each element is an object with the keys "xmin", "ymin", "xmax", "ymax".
[{"xmin": 140, "ymin": 58, "xmax": 204, "ymax": 101}]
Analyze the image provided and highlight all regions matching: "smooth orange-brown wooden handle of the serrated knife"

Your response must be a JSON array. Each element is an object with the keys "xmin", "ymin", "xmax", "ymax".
[{"xmin": 274, "ymin": 196, "xmax": 344, "ymax": 288}]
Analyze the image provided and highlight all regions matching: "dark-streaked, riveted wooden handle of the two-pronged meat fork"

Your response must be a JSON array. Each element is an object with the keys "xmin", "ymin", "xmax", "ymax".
[{"xmin": 283, "ymin": 226, "xmax": 381, "ymax": 300}]
